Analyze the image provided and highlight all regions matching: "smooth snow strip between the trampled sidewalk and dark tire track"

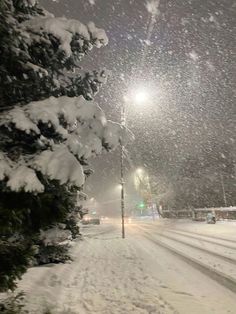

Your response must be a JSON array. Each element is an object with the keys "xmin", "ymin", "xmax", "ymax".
[{"xmin": 129, "ymin": 224, "xmax": 236, "ymax": 314}]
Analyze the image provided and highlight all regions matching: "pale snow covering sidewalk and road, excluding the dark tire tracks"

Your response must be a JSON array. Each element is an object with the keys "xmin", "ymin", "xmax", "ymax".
[{"xmin": 4, "ymin": 221, "xmax": 236, "ymax": 314}]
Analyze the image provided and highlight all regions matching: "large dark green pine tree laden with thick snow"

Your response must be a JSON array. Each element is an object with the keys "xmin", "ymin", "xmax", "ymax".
[{"xmin": 0, "ymin": 0, "xmax": 123, "ymax": 291}]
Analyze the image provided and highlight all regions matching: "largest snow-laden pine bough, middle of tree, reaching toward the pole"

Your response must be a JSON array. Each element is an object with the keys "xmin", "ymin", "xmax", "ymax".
[{"xmin": 0, "ymin": 96, "xmax": 126, "ymax": 192}]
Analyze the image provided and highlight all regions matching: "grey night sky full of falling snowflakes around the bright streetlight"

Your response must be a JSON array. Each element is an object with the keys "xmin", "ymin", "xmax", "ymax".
[{"xmin": 40, "ymin": 0, "xmax": 236, "ymax": 211}]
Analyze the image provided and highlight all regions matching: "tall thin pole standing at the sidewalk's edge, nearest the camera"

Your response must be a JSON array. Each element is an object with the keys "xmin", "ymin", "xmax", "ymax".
[{"xmin": 120, "ymin": 103, "xmax": 125, "ymax": 239}]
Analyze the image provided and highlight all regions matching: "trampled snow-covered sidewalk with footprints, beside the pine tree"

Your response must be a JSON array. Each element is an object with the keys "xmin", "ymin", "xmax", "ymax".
[{"xmin": 16, "ymin": 225, "xmax": 175, "ymax": 314}]
